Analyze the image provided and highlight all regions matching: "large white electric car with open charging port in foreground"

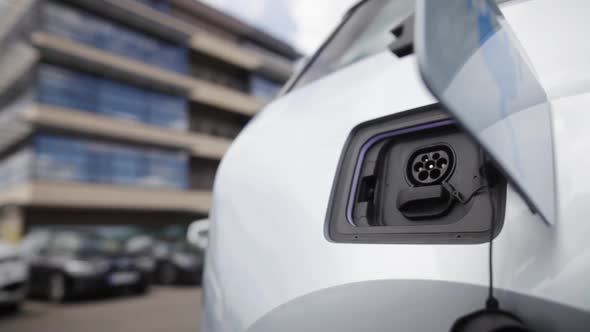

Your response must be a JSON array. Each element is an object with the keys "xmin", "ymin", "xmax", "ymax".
[{"xmin": 203, "ymin": 0, "xmax": 590, "ymax": 332}]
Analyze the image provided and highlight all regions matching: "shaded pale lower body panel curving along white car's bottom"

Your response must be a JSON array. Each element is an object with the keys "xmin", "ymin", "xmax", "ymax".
[{"xmin": 249, "ymin": 280, "xmax": 590, "ymax": 332}]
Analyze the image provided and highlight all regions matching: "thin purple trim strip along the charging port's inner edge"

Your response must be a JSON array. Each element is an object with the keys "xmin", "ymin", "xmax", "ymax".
[{"xmin": 346, "ymin": 120, "xmax": 455, "ymax": 226}]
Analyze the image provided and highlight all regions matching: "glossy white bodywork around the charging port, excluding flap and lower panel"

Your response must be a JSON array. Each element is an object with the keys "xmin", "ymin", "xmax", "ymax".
[{"xmin": 205, "ymin": 0, "xmax": 590, "ymax": 331}]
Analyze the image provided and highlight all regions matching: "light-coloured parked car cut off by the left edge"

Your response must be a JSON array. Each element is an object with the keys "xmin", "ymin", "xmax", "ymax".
[{"xmin": 0, "ymin": 241, "xmax": 29, "ymax": 311}]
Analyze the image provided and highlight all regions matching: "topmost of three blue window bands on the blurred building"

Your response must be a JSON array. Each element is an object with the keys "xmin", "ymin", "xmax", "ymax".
[{"xmin": 43, "ymin": 1, "xmax": 189, "ymax": 73}]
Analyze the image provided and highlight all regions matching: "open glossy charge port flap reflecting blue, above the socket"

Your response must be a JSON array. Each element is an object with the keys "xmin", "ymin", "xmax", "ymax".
[{"xmin": 415, "ymin": 0, "xmax": 556, "ymax": 223}]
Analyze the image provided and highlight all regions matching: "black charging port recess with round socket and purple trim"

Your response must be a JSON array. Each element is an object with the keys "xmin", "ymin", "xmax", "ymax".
[{"xmin": 326, "ymin": 107, "xmax": 506, "ymax": 243}]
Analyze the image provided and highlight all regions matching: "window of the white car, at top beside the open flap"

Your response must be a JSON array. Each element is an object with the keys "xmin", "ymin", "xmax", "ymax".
[{"xmin": 293, "ymin": 0, "xmax": 415, "ymax": 88}]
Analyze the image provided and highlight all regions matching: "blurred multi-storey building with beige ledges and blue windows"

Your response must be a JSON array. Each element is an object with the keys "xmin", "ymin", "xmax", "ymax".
[{"xmin": 0, "ymin": 0, "xmax": 299, "ymax": 240}]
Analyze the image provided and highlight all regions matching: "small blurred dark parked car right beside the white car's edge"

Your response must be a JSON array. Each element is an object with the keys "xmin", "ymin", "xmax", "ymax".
[{"xmin": 154, "ymin": 241, "xmax": 205, "ymax": 285}]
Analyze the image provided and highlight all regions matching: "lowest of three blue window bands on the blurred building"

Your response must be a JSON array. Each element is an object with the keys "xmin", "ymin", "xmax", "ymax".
[{"xmin": 35, "ymin": 134, "xmax": 189, "ymax": 189}]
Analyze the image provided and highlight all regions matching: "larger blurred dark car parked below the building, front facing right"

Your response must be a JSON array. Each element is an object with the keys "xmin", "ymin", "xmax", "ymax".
[{"xmin": 23, "ymin": 230, "xmax": 153, "ymax": 302}]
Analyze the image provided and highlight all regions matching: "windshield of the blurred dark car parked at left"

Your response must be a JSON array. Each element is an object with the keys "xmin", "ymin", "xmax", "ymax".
[{"xmin": 51, "ymin": 231, "xmax": 122, "ymax": 254}]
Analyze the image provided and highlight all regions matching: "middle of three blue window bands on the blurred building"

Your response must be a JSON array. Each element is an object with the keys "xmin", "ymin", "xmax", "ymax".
[{"xmin": 37, "ymin": 65, "xmax": 188, "ymax": 131}]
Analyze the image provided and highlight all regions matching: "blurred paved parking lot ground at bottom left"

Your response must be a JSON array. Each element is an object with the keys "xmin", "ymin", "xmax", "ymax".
[{"xmin": 0, "ymin": 287, "xmax": 201, "ymax": 332}]
